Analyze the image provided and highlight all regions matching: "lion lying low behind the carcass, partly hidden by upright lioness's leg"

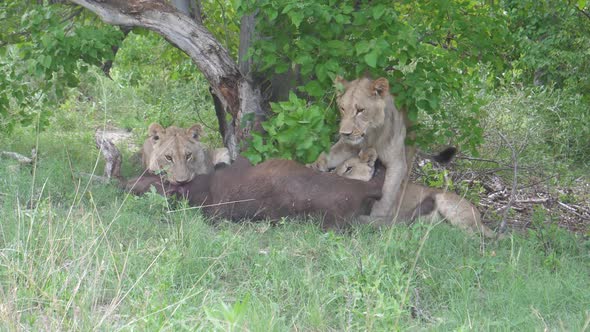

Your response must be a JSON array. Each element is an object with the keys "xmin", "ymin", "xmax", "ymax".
[{"xmin": 335, "ymin": 149, "xmax": 496, "ymax": 238}]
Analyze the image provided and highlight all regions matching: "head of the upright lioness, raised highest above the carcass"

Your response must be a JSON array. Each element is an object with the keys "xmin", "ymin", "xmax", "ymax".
[{"xmin": 335, "ymin": 76, "xmax": 390, "ymax": 145}]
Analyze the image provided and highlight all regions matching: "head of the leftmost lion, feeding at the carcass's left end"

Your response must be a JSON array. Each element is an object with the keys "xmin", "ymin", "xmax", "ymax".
[{"xmin": 142, "ymin": 123, "xmax": 213, "ymax": 184}]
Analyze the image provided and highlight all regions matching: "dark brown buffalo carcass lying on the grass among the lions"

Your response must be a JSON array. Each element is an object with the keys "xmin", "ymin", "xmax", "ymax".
[{"xmin": 127, "ymin": 158, "xmax": 383, "ymax": 228}]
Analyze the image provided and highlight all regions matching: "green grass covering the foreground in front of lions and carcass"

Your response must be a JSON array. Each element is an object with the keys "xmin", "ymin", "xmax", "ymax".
[{"xmin": 0, "ymin": 132, "xmax": 590, "ymax": 331}]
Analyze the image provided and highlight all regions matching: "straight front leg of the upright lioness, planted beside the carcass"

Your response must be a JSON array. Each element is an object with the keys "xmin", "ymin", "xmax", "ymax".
[{"xmin": 371, "ymin": 153, "xmax": 407, "ymax": 218}]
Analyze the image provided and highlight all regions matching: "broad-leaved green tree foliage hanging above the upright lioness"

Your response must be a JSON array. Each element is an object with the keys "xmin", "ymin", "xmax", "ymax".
[{"xmin": 241, "ymin": 0, "xmax": 508, "ymax": 157}]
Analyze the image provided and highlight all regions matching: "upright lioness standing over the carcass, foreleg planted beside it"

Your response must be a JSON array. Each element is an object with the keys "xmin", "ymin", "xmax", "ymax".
[{"xmin": 310, "ymin": 77, "xmax": 413, "ymax": 218}]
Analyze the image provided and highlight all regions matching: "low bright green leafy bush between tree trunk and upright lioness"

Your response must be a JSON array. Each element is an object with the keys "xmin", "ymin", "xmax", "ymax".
[{"xmin": 242, "ymin": 93, "xmax": 336, "ymax": 164}]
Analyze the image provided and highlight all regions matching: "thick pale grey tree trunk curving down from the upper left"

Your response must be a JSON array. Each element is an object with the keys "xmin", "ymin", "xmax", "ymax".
[{"xmin": 70, "ymin": 0, "xmax": 264, "ymax": 159}]
